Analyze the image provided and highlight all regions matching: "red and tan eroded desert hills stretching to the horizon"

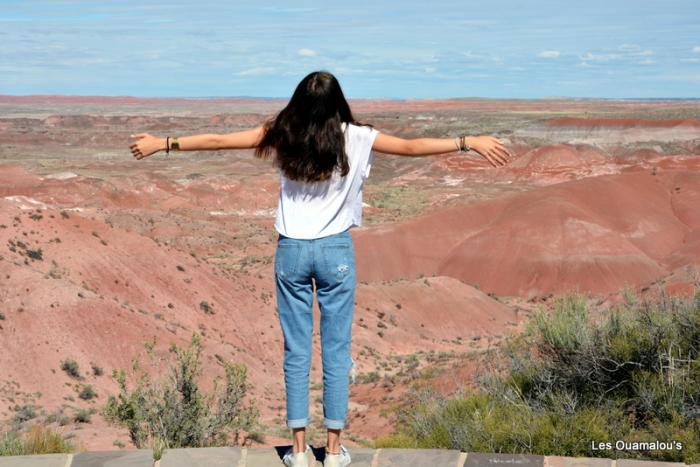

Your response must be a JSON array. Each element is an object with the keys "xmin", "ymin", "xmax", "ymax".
[{"xmin": 0, "ymin": 96, "xmax": 700, "ymax": 450}]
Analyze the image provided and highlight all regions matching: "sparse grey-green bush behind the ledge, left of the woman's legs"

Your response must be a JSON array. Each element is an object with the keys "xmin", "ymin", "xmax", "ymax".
[{"xmin": 103, "ymin": 335, "xmax": 259, "ymax": 448}]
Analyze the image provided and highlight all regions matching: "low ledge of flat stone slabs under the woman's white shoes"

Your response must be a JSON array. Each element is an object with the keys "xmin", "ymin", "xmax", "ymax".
[{"xmin": 0, "ymin": 445, "xmax": 700, "ymax": 467}]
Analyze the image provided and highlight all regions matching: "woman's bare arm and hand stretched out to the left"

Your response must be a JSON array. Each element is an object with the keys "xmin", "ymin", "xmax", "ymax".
[{"xmin": 129, "ymin": 126, "xmax": 264, "ymax": 159}]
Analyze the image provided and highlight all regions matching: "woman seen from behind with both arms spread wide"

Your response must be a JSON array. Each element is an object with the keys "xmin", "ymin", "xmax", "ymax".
[{"xmin": 130, "ymin": 71, "xmax": 512, "ymax": 467}]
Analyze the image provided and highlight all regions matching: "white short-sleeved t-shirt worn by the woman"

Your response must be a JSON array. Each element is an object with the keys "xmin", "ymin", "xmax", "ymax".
[{"xmin": 275, "ymin": 122, "xmax": 379, "ymax": 239}]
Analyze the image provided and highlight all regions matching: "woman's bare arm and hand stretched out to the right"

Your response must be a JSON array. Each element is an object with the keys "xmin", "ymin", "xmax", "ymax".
[{"xmin": 372, "ymin": 133, "xmax": 513, "ymax": 167}]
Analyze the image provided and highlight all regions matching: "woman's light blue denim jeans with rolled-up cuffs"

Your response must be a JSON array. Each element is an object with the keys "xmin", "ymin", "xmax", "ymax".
[{"xmin": 275, "ymin": 229, "xmax": 356, "ymax": 429}]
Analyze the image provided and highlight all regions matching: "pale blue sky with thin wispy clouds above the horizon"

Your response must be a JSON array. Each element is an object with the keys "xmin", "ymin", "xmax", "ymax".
[{"xmin": 0, "ymin": 0, "xmax": 700, "ymax": 98}]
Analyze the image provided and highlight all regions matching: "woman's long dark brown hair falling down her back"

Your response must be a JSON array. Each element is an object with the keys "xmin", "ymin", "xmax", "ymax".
[{"xmin": 255, "ymin": 71, "xmax": 372, "ymax": 182}]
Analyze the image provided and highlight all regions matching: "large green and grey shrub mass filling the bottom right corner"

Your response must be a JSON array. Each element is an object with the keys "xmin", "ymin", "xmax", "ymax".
[{"xmin": 375, "ymin": 292, "xmax": 700, "ymax": 463}]
